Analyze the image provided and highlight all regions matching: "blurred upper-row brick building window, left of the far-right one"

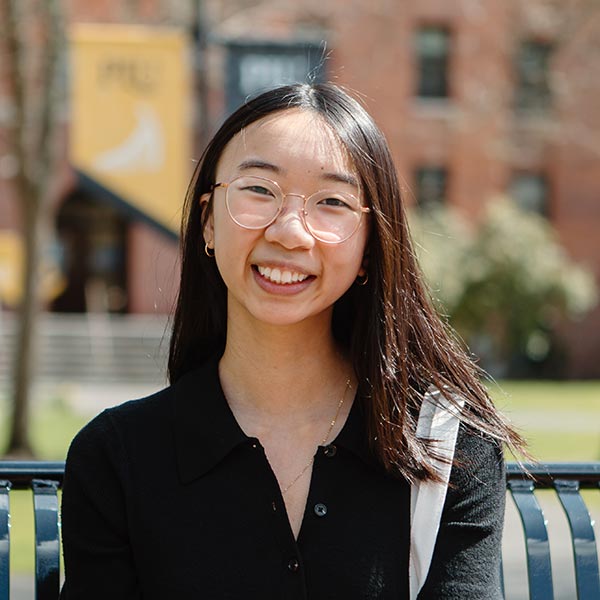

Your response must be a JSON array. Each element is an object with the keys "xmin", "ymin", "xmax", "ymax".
[{"xmin": 416, "ymin": 27, "xmax": 450, "ymax": 98}]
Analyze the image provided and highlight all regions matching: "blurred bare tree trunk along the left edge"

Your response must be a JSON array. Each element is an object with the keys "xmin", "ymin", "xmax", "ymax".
[{"xmin": 0, "ymin": 0, "xmax": 64, "ymax": 458}]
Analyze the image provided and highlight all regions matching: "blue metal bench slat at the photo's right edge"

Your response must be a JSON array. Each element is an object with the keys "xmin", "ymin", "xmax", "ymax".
[{"xmin": 554, "ymin": 479, "xmax": 600, "ymax": 598}]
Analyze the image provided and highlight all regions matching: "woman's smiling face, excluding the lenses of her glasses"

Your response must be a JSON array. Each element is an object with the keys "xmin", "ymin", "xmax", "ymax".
[{"xmin": 203, "ymin": 108, "xmax": 368, "ymax": 326}]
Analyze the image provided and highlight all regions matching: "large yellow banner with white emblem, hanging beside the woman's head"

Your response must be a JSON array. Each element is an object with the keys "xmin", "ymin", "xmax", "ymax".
[{"xmin": 70, "ymin": 24, "xmax": 193, "ymax": 231}]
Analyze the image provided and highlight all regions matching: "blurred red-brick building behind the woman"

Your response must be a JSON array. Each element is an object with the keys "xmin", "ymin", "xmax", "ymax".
[{"xmin": 0, "ymin": 0, "xmax": 600, "ymax": 377}]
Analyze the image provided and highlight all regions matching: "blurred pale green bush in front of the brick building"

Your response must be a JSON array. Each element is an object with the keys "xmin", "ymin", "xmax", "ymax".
[{"xmin": 411, "ymin": 198, "xmax": 598, "ymax": 376}]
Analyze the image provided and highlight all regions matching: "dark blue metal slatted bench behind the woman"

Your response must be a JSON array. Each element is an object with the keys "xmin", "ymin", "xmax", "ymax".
[{"xmin": 0, "ymin": 461, "xmax": 600, "ymax": 600}]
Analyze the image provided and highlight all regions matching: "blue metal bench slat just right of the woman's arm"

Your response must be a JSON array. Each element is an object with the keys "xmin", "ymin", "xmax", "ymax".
[{"xmin": 508, "ymin": 479, "xmax": 554, "ymax": 600}]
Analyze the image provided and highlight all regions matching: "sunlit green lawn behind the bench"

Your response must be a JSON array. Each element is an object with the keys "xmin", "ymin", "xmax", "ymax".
[{"xmin": 0, "ymin": 381, "xmax": 600, "ymax": 573}]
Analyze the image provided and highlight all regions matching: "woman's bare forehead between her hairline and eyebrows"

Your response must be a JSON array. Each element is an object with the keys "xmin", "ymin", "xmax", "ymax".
[{"xmin": 217, "ymin": 108, "xmax": 355, "ymax": 177}]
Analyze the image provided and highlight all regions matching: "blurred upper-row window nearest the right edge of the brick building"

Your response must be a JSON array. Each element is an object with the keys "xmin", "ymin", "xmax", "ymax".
[{"xmin": 515, "ymin": 40, "xmax": 553, "ymax": 111}]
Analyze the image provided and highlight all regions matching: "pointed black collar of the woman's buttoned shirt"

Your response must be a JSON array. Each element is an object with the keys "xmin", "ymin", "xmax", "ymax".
[{"xmin": 173, "ymin": 357, "xmax": 374, "ymax": 483}]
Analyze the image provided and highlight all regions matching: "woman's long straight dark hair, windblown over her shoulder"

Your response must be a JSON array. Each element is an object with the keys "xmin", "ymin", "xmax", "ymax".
[{"xmin": 169, "ymin": 84, "xmax": 523, "ymax": 481}]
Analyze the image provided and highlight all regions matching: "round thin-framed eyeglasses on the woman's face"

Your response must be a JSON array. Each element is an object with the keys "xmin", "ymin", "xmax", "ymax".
[{"xmin": 213, "ymin": 175, "xmax": 371, "ymax": 244}]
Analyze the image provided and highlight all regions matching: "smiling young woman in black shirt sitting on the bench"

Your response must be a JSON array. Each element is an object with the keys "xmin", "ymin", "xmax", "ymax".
[{"xmin": 61, "ymin": 84, "xmax": 521, "ymax": 600}]
